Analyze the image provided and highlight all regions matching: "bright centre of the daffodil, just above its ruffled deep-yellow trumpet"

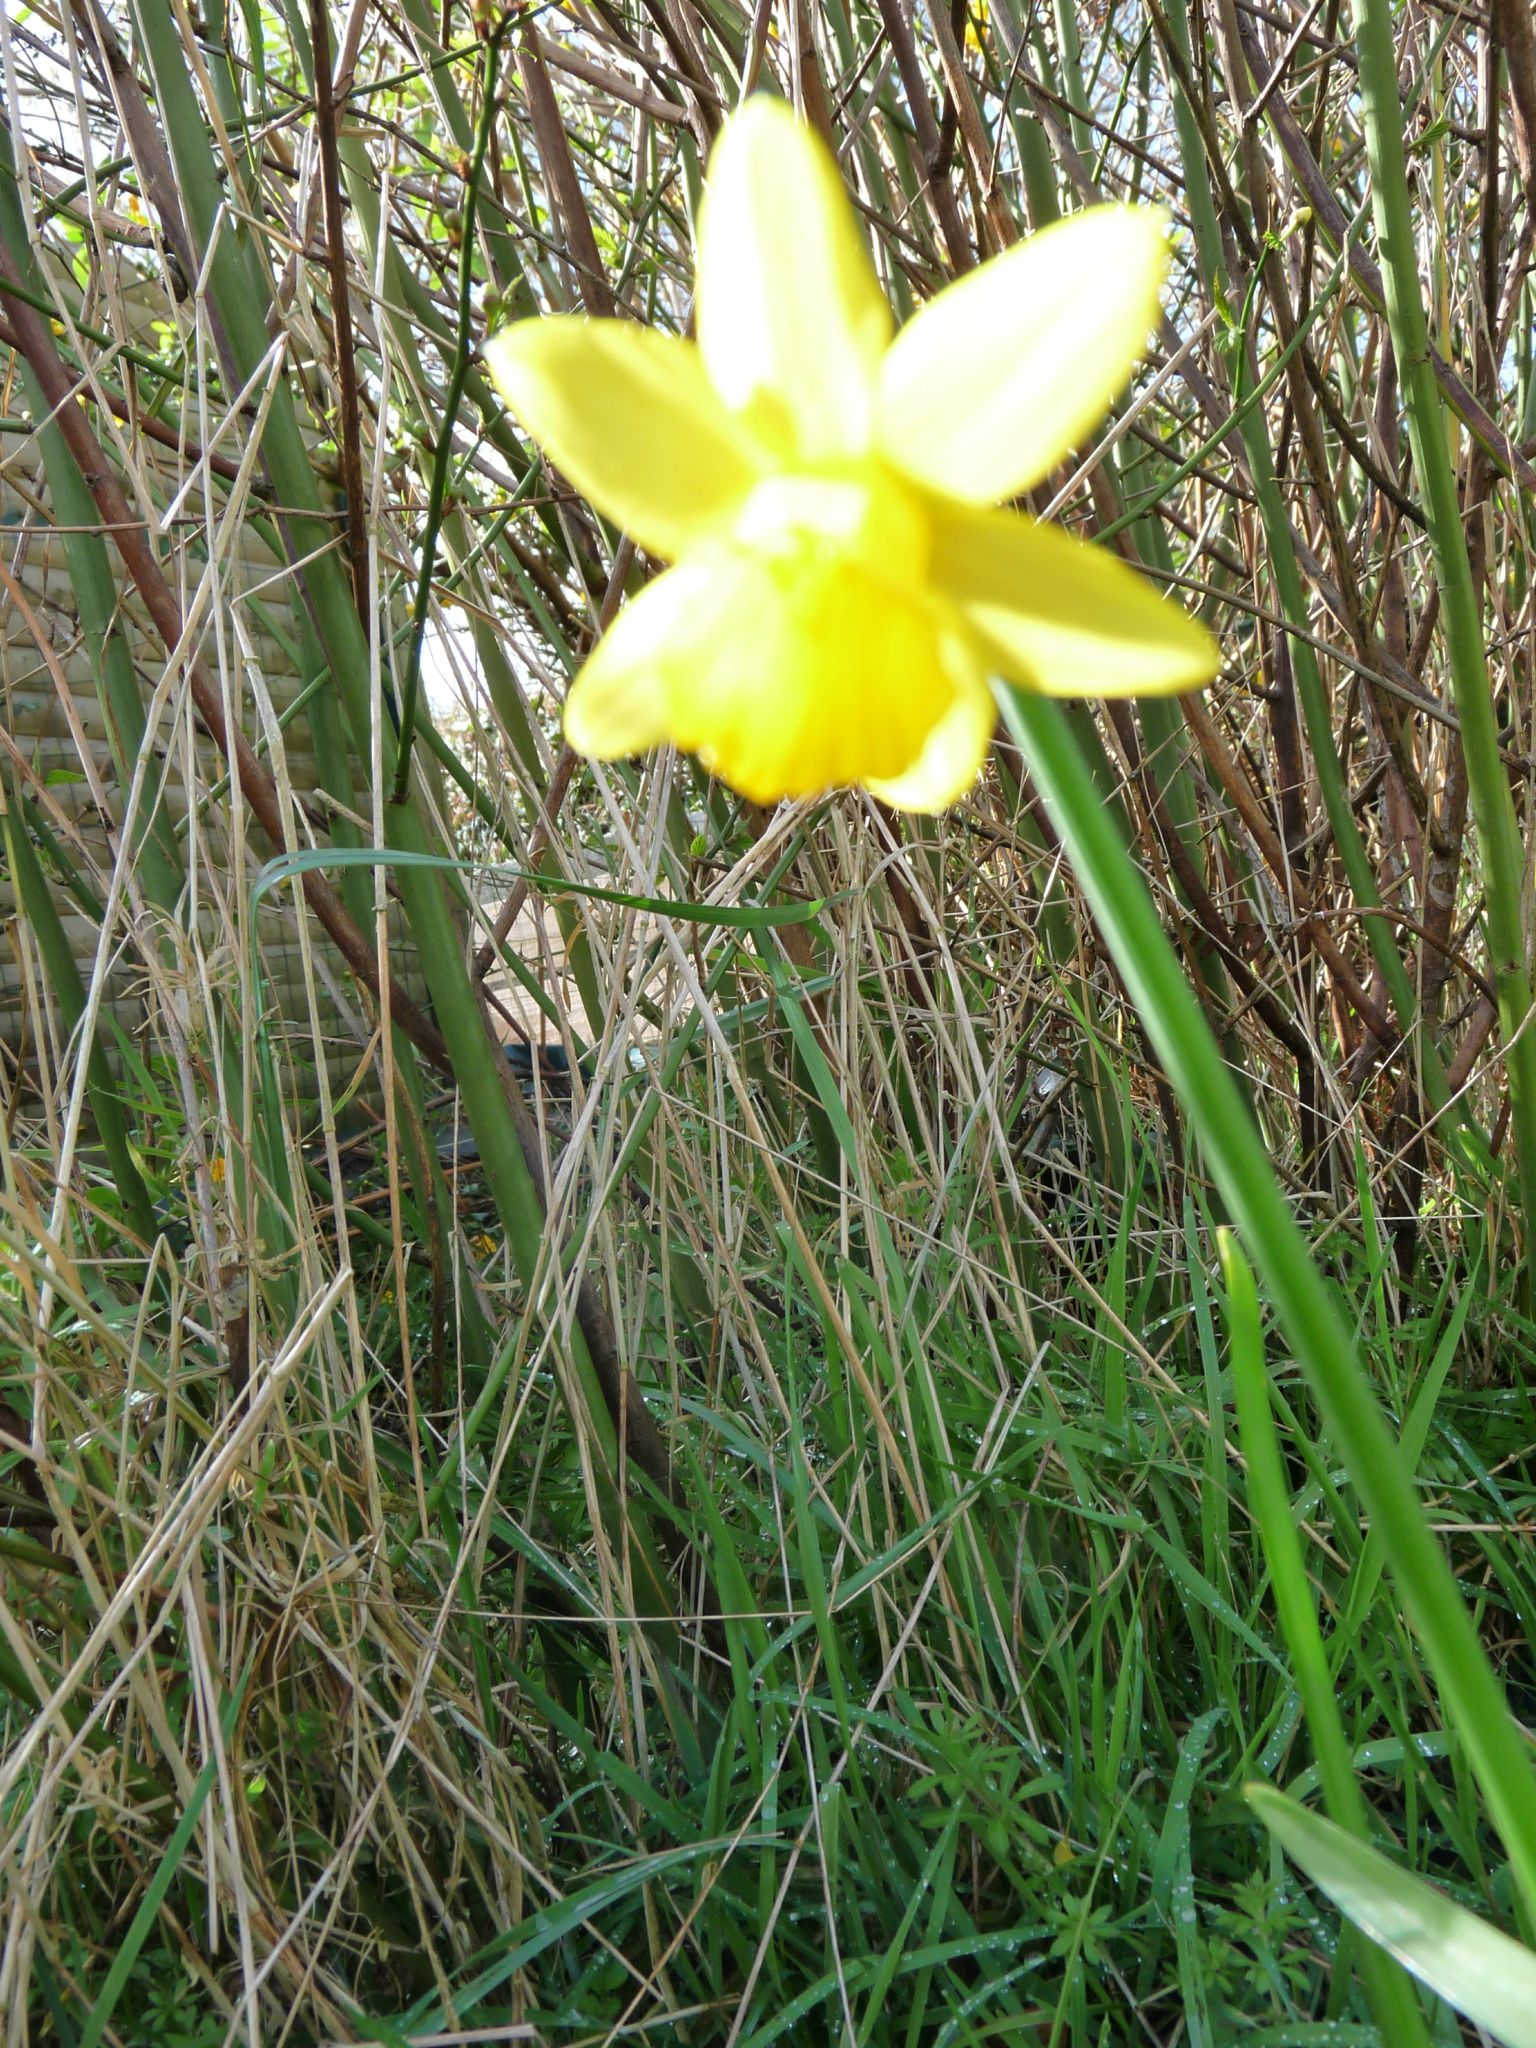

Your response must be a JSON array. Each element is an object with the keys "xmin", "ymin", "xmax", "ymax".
[{"xmin": 731, "ymin": 463, "xmax": 930, "ymax": 588}]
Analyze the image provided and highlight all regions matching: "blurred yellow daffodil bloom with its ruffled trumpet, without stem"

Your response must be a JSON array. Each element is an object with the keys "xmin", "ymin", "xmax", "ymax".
[{"xmin": 485, "ymin": 98, "xmax": 1217, "ymax": 811}]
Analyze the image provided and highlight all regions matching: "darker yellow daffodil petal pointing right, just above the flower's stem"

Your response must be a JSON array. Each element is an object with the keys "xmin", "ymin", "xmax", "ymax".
[{"xmin": 930, "ymin": 506, "xmax": 1221, "ymax": 696}]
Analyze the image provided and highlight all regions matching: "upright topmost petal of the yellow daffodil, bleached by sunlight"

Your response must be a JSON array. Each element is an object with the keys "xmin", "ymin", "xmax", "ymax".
[{"xmin": 698, "ymin": 94, "xmax": 891, "ymax": 461}]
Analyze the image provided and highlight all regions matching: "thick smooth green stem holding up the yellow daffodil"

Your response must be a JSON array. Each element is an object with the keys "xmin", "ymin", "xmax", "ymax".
[{"xmin": 1001, "ymin": 690, "xmax": 1536, "ymax": 1915}]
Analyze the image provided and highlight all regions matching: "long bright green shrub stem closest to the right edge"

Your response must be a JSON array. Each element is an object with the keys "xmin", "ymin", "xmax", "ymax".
[{"xmin": 1354, "ymin": 0, "xmax": 1536, "ymax": 1292}]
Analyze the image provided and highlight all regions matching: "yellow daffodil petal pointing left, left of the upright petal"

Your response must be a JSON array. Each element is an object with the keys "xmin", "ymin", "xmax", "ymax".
[{"xmin": 485, "ymin": 315, "xmax": 762, "ymax": 561}]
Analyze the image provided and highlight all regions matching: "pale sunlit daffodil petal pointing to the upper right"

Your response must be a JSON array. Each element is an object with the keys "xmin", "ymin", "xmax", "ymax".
[{"xmin": 879, "ymin": 207, "xmax": 1167, "ymax": 504}]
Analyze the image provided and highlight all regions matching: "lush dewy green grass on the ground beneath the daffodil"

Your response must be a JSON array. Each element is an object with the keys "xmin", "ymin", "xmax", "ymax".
[{"xmin": 333, "ymin": 1105, "xmax": 1530, "ymax": 2042}]
